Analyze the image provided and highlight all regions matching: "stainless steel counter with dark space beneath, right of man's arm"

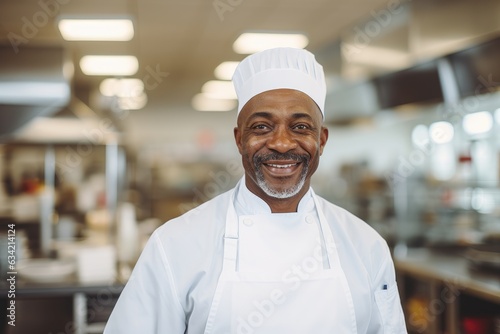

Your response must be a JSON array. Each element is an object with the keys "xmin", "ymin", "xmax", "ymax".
[{"xmin": 394, "ymin": 248, "xmax": 500, "ymax": 334}]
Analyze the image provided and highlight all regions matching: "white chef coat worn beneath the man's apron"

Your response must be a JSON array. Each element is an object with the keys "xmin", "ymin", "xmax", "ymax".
[{"xmin": 104, "ymin": 179, "xmax": 406, "ymax": 334}]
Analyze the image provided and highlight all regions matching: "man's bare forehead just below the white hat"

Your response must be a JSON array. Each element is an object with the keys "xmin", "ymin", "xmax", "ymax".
[{"xmin": 238, "ymin": 89, "xmax": 323, "ymax": 120}]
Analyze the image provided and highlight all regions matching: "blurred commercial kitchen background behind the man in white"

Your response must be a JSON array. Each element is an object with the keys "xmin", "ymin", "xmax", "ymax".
[{"xmin": 0, "ymin": 0, "xmax": 500, "ymax": 334}]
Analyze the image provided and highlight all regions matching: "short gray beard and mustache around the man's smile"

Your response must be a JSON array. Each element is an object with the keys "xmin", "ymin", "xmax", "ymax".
[{"xmin": 254, "ymin": 154, "xmax": 309, "ymax": 199}]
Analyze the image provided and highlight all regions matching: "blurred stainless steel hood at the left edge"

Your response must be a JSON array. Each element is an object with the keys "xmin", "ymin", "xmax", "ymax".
[{"xmin": 0, "ymin": 44, "xmax": 73, "ymax": 142}]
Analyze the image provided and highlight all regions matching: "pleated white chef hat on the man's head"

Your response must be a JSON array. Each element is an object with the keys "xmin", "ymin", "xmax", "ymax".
[{"xmin": 233, "ymin": 48, "xmax": 326, "ymax": 118}]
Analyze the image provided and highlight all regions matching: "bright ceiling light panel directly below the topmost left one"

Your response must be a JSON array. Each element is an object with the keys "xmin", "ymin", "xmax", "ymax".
[{"xmin": 80, "ymin": 56, "xmax": 139, "ymax": 75}]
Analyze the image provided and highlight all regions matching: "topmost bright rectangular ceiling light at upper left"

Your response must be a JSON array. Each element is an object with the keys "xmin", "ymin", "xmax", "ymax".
[{"xmin": 58, "ymin": 19, "xmax": 134, "ymax": 41}]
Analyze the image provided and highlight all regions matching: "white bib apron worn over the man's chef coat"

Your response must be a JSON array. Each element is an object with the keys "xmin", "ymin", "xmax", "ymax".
[{"xmin": 204, "ymin": 191, "xmax": 357, "ymax": 334}]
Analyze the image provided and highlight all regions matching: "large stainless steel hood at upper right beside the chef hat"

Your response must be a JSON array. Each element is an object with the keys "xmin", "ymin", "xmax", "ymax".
[{"xmin": 319, "ymin": 0, "xmax": 500, "ymax": 124}]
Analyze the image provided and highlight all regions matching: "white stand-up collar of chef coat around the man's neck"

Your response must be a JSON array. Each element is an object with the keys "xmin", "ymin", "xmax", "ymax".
[{"xmin": 235, "ymin": 176, "xmax": 314, "ymax": 215}]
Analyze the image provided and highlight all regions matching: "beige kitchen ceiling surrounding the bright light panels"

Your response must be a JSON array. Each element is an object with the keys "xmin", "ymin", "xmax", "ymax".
[{"xmin": 0, "ymin": 0, "xmax": 387, "ymax": 87}]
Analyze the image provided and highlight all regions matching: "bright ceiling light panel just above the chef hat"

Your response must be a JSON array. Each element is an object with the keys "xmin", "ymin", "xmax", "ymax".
[{"xmin": 233, "ymin": 33, "xmax": 309, "ymax": 54}]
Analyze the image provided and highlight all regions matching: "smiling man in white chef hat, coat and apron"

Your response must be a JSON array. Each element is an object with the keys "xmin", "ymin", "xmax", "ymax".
[{"xmin": 105, "ymin": 48, "xmax": 406, "ymax": 334}]
